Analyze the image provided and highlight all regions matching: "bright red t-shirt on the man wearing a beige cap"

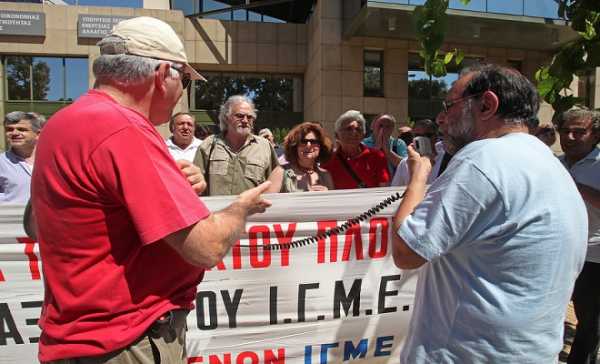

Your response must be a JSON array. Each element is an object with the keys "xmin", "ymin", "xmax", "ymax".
[{"xmin": 32, "ymin": 90, "xmax": 210, "ymax": 361}]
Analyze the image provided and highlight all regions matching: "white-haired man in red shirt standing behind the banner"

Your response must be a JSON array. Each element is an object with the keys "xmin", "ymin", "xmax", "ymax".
[{"xmin": 323, "ymin": 110, "xmax": 390, "ymax": 190}]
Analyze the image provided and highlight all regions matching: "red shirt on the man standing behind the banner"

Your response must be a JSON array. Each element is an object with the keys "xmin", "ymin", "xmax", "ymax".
[{"xmin": 322, "ymin": 144, "xmax": 390, "ymax": 190}]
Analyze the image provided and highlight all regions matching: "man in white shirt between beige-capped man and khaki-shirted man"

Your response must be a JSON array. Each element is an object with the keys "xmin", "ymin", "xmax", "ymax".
[{"xmin": 165, "ymin": 112, "xmax": 202, "ymax": 162}]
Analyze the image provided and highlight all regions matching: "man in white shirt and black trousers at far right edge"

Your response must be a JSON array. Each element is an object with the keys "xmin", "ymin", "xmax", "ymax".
[{"xmin": 558, "ymin": 109, "xmax": 600, "ymax": 364}]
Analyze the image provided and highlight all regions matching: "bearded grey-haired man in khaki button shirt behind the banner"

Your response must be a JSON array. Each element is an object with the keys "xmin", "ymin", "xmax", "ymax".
[{"xmin": 194, "ymin": 95, "xmax": 282, "ymax": 196}]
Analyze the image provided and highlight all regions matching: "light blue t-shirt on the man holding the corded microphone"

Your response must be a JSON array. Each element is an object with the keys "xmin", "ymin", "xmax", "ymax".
[{"xmin": 398, "ymin": 133, "xmax": 587, "ymax": 364}]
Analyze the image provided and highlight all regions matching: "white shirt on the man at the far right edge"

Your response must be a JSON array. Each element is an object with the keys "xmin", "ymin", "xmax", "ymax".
[{"xmin": 558, "ymin": 146, "xmax": 600, "ymax": 263}]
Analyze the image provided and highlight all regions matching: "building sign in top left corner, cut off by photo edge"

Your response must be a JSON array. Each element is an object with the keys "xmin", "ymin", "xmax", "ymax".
[{"xmin": 0, "ymin": 10, "xmax": 46, "ymax": 36}]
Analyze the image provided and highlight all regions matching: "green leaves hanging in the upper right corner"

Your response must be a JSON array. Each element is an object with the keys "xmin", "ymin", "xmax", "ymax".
[{"xmin": 535, "ymin": 0, "xmax": 600, "ymax": 115}]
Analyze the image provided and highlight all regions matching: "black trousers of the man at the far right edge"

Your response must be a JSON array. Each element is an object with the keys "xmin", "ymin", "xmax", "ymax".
[{"xmin": 567, "ymin": 262, "xmax": 600, "ymax": 364}]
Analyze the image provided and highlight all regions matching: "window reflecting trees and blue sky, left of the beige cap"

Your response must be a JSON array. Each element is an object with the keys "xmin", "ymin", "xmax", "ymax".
[{"xmin": 4, "ymin": 56, "xmax": 88, "ymax": 101}]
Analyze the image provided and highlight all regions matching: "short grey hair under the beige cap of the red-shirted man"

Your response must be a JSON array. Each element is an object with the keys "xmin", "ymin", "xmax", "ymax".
[{"xmin": 92, "ymin": 35, "xmax": 177, "ymax": 85}]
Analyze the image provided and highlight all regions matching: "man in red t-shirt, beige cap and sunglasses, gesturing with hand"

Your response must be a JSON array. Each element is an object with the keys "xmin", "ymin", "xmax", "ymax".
[{"xmin": 32, "ymin": 17, "xmax": 270, "ymax": 363}]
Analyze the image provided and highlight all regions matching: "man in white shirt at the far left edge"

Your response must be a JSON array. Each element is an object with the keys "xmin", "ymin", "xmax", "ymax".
[{"xmin": 0, "ymin": 111, "xmax": 44, "ymax": 204}]
